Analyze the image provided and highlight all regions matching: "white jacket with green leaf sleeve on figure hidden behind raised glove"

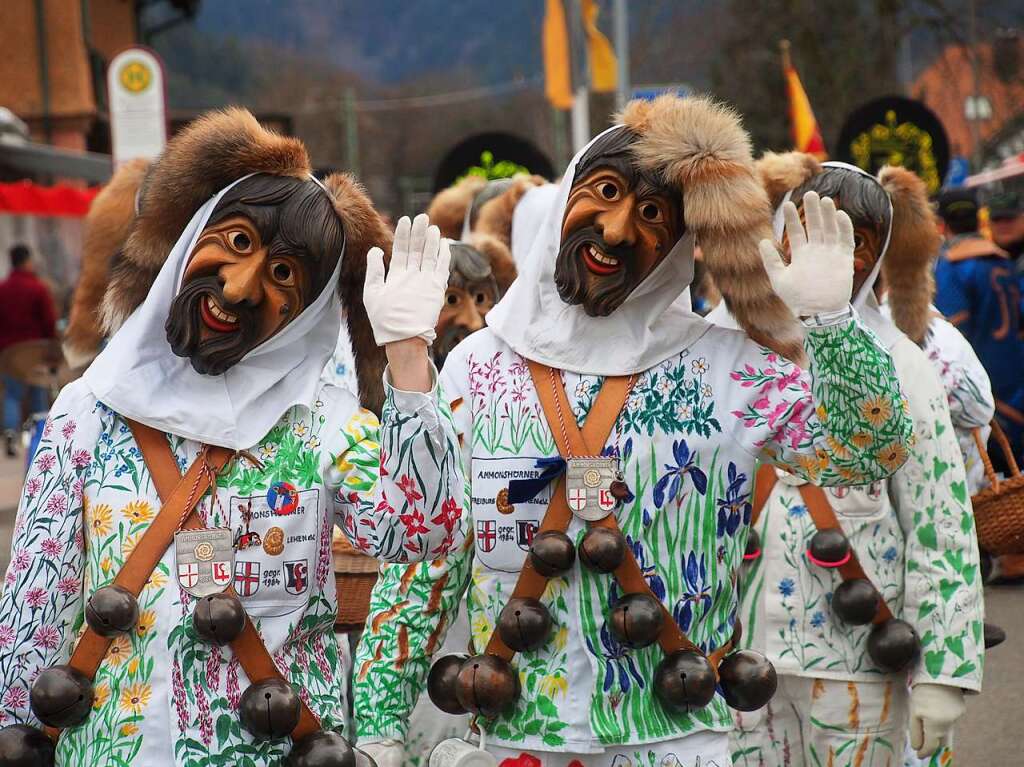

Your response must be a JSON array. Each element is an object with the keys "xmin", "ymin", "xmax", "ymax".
[{"xmin": 740, "ymin": 336, "xmax": 983, "ymax": 690}]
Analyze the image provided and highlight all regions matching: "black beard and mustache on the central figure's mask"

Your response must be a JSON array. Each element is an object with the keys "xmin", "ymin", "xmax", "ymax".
[{"xmin": 555, "ymin": 226, "xmax": 645, "ymax": 316}]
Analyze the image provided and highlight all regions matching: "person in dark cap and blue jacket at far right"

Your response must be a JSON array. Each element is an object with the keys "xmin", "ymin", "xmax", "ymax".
[{"xmin": 935, "ymin": 189, "xmax": 1024, "ymax": 463}]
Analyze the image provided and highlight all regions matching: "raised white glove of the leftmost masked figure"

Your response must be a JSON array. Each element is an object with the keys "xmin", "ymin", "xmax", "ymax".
[{"xmin": 362, "ymin": 213, "xmax": 452, "ymax": 346}]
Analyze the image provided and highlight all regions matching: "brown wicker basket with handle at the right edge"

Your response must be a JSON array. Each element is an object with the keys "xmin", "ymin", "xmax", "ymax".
[{"xmin": 971, "ymin": 421, "xmax": 1024, "ymax": 556}]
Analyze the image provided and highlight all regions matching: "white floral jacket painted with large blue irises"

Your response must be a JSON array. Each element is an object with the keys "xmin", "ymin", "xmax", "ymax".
[{"xmin": 354, "ymin": 316, "xmax": 910, "ymax": 753}]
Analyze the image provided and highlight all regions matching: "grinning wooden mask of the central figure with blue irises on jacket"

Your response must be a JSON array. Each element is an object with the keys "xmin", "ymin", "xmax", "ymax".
[{"xmin": 555, "ymin": 128, "xmax": 686, "ymax": 316}]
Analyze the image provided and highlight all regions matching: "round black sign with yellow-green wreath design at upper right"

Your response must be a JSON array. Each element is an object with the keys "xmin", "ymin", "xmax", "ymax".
[{"xmin": 836, "ymin": 96, "xmax": 949, "ymax": 195}]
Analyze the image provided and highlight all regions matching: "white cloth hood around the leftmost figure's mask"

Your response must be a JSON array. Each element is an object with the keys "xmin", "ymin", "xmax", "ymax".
[{"xmin": 83, "ymin": 179, "xmax": 344, "ymax": 450}]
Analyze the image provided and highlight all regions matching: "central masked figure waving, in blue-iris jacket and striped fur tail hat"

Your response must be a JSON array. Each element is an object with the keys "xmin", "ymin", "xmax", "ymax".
[{"xmin": 354, "ymin": 96, "xmax": 910, "ymax": 767}]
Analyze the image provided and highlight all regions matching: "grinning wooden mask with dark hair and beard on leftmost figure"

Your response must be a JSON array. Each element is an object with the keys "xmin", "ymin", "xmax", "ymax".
[{"xmin": 166, "ymin": 174, "xmax": 345, "ymax": 375}]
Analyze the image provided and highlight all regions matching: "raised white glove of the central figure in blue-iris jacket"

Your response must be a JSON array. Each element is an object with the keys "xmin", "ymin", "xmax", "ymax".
[{"xmin": 759, "ymin": 191, "xmax": 854, "ymax": 317}]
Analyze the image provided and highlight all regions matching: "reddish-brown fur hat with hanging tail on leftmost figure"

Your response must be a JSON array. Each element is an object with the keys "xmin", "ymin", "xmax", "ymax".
[{"xmin": 102, "ymin": 108, "xmax": 391, "ymax": 413}]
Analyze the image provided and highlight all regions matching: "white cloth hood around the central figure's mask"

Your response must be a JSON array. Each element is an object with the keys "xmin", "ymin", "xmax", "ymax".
[{"xmin": 487, "ymin": 126, "xmax": 711, "ymax": 376}]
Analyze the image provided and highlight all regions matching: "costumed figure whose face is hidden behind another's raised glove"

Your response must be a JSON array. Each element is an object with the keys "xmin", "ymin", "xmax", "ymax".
[{"xmin": 712, "ymin": 155, "xmax": 983, "ymax": 767}]
